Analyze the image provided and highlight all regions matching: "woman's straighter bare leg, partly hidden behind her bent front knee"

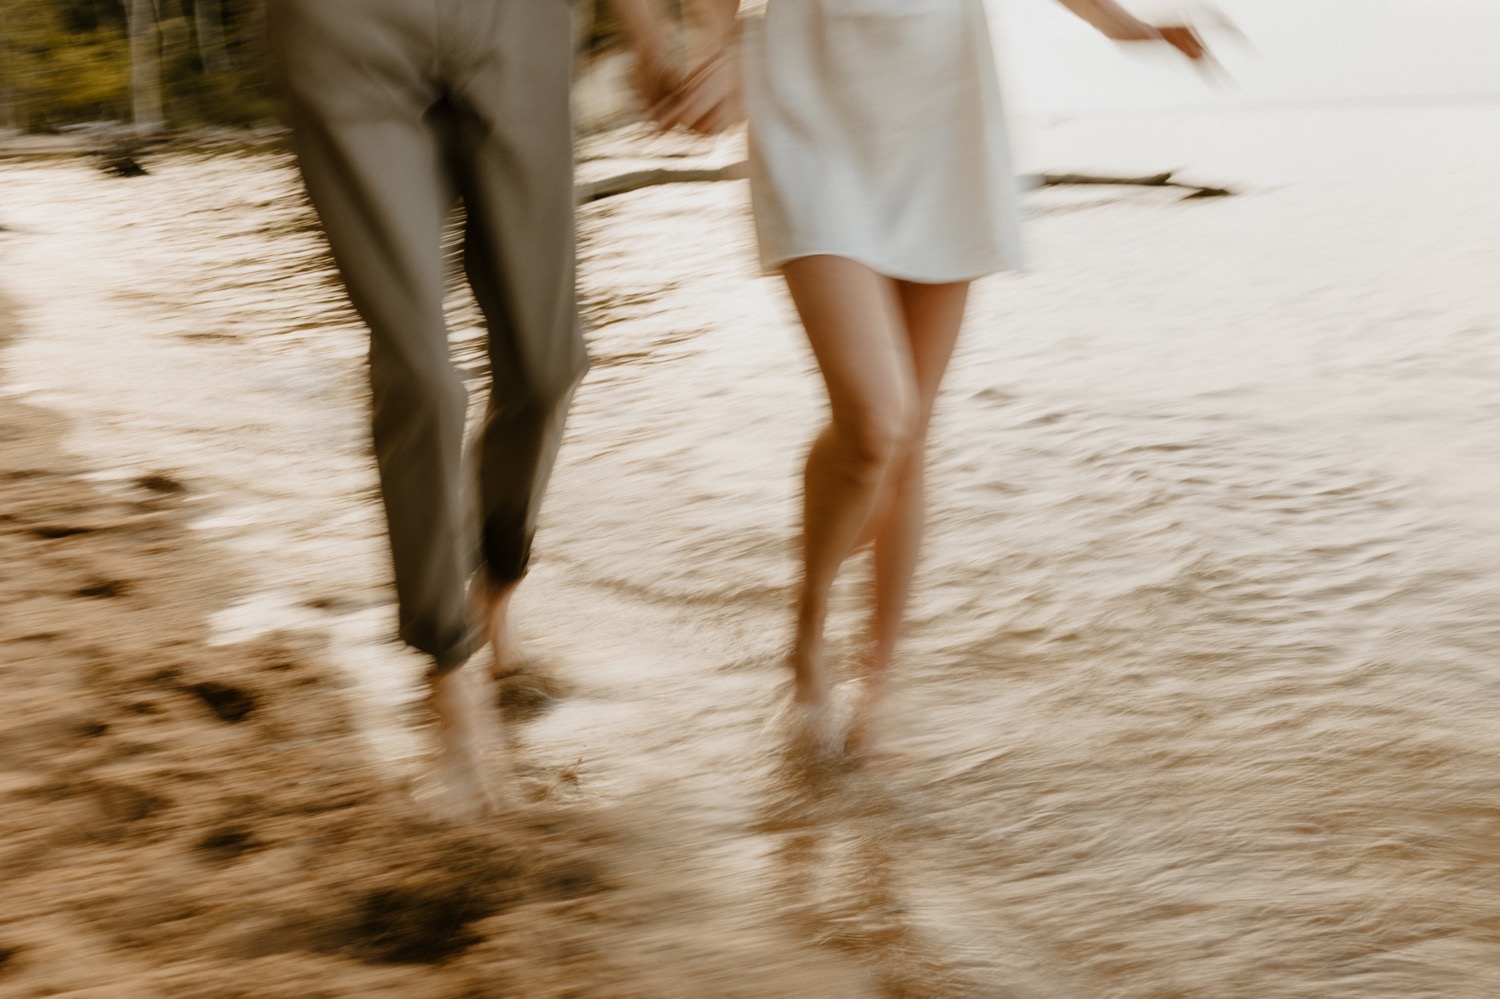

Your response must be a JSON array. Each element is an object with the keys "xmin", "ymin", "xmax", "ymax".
[{"xmin": 854, "ymin": 282, "xmax": 969, "ymax": 741}]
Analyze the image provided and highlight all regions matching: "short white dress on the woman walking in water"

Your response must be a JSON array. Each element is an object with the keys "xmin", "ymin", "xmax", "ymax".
[{"xmin": 743, "ymin": 0, "xmax": 1022, "ymax": 284}]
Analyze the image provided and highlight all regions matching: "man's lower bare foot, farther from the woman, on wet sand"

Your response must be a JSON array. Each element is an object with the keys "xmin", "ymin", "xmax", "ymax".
[{"xmin": 419, "ymin": 668, "xmax": 509, "ymax": 821}]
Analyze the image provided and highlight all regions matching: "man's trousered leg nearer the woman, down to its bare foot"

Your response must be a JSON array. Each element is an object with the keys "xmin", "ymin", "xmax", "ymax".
[{"xmin": 453, "ymin": 0, "xmax": 588, "ymax": 672}]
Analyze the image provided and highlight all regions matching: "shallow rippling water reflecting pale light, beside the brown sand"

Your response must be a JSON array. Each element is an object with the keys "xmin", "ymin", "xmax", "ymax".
[{"xmin": 0, "ymin": 105, "xmax": 1500, "ymax": 999}]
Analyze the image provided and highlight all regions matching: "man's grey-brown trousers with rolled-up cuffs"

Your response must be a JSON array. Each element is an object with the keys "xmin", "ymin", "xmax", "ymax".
[{"xmin": 269, "ymin": 0, "xmax": 588, "ymax": 669}]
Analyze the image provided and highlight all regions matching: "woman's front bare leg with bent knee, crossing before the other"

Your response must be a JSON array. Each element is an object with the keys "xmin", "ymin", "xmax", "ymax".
[{"xmin": 783, "ymin": 257, "xmax": 917, "ymax": 717}]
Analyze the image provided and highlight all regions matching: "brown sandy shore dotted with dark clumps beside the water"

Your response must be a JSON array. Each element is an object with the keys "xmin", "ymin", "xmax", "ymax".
[{"xmin": 0, "ymin": 292, "xmax": 891, "ymax": 999}]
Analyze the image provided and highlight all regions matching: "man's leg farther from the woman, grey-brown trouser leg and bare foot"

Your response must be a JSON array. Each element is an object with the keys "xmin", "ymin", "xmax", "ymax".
[{"xmin": 272, "ymin": 0, "xmax": 494, "ymax": 815}]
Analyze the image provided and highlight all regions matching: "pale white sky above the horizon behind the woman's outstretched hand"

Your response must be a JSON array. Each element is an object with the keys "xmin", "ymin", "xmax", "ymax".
[{"xmin": 987, "ymin": 0, "xmax": 1500, "ymax": 114}]
